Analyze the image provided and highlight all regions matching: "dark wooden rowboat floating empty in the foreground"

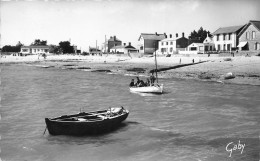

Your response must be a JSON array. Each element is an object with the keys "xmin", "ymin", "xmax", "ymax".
[{"xmin": 45, "ymin": 107, "xmax": 129, "ymax": 136}]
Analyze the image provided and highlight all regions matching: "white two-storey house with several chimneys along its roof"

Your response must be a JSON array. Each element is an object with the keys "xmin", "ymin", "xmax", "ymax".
[{"xmin": 157, "ymin": 33, "xmax": 188, "ymax": 55}]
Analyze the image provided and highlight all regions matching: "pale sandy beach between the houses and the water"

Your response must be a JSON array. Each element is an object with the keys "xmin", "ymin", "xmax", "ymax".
[{"xmin": 0, "ymin": 55, "xmax": 260, "ymax": 85}]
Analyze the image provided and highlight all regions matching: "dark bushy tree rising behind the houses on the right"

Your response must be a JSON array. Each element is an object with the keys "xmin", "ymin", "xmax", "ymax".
[{"xmin": 189, "ymin": 27, "xmax": 212, "ymax": 44}]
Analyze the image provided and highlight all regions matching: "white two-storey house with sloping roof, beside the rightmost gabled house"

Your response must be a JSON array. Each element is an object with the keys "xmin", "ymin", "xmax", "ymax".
[{"xmin": 213, "ymin": 26, "xmax": 244, "ymax": 51}]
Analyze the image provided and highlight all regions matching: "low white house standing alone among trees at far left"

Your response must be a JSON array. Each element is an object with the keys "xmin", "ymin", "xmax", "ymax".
[{"xmin": 20, "ymin": 45, "xmax": 49, "ymax": 55}]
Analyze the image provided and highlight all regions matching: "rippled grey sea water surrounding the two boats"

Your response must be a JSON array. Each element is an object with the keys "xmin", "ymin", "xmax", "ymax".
[{"xmin": 0, "ymin": 64, "xmax": 260, "ymax": 161}]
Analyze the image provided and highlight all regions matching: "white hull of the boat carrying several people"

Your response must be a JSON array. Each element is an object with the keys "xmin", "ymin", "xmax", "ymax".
[{"xmin": 130, "ymin": 84, "xmax": 163, "ymax": 94}]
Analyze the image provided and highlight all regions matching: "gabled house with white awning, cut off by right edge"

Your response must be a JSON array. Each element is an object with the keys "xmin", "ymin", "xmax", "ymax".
[{"xmin": 237, "ymin": 21, "xmax": 260, "ymax": 51}]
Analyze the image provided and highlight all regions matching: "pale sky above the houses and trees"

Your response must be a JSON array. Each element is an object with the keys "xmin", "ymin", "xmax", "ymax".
[{"xmin": 0, "ymin": 0, "xmax": 260, "ymax": 51}]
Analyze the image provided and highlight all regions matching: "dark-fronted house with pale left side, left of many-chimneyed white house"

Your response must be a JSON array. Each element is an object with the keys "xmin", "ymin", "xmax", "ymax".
[{"xmin": 138, "ymin": 32, "xmax": 166, "ymax": 55}]
